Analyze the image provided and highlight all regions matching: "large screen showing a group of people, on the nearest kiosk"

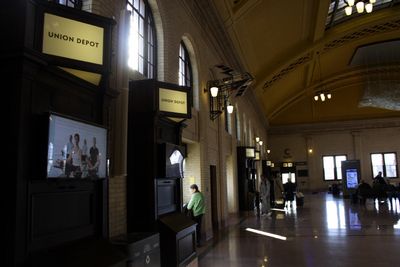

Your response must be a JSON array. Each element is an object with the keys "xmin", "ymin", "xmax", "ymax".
[{"xmin": 47, "ymin": 114, "xmax": 107, "ymax": 179}]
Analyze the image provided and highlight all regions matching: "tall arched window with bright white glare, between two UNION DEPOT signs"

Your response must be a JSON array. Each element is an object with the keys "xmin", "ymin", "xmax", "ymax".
[{"xmin": 126, "ymin": 0, "xmax": 156, "ymax": 79}]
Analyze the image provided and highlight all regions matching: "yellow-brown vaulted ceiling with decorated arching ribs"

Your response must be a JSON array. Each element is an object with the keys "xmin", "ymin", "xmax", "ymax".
[{"xmin": 214, "ymin": 0, "xmax": 400, "ymax": 126}]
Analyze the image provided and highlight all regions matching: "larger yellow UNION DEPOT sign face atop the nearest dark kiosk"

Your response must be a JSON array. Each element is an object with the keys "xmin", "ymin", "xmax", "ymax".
[{"xmin": 42, "ymin": 13, "xmax": 104, "ymax": 65}]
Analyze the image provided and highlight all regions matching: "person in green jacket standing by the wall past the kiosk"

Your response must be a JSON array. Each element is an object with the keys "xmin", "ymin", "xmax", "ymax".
[{"xmin": 187, "ymin": 184, "xmax": 206, "ymax": 246}]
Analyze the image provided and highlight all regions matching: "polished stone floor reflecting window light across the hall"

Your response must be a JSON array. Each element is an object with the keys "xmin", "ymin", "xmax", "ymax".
[{"xmin": 198, "ymin": 193, "xmax": 400, "ymax": 267}]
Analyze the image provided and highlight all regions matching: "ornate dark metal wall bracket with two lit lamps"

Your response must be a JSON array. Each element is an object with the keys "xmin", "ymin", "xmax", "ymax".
[{"xmin": 204, "ymin": 65, "xmax": 253, "ymax": 120}]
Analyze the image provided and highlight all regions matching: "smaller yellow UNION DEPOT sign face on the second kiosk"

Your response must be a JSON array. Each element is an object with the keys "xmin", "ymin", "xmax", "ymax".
[{"xmin": 159, "ymin": 88, "xmax": 187, "ymax": 114}]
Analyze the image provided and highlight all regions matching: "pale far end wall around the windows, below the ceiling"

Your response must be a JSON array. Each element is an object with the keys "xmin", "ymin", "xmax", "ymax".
[{"xmin": 268, "ymin": 118, "xmax": 400, "ymax": 191}]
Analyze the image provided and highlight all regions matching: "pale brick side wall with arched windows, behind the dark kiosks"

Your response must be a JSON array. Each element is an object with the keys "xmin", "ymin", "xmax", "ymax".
[{"xmin": 94, "ymin": 0, "xmax": 266, "ymax": 241}]
